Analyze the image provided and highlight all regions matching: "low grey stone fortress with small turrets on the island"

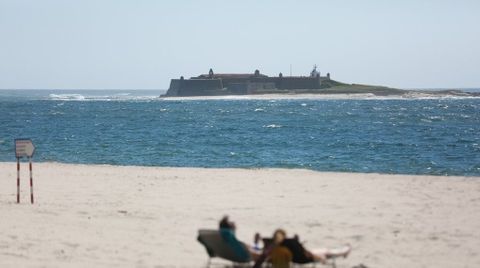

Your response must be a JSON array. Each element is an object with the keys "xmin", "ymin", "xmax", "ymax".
[{"xmin": 164, "ymin": 65, "xmax": 333, "ymax": 97}]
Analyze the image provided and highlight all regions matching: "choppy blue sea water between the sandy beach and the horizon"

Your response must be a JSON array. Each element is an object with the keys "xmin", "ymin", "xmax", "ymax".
[{"xmin": 0, "ymin": 90, "xmax": 480, "ymax": 176}]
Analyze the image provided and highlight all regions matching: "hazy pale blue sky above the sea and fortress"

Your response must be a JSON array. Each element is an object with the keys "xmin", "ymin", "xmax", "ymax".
[{"xmin": 0, "ymin": 0, "xmax": 480, "ymax": 89}]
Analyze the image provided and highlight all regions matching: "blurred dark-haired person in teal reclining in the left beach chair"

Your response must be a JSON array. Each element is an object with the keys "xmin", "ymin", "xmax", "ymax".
[{"xmin": 219, "ymin": 216, "xmax": 260, "ymax": 260}]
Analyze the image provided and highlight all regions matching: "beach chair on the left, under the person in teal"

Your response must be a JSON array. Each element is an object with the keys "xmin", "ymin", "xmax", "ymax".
[{"xmin": 197, "ymin": 230, "xmax": 252, "ymax": 267}]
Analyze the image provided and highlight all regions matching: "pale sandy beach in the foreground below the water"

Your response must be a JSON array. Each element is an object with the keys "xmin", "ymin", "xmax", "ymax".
[{"xmin": 0, "ymin": 163, "xmax": 480, "ymax": 268}]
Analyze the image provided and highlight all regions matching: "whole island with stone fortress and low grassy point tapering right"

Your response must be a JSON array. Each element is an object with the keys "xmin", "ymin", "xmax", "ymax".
[{"xmin": 160, "ymin": 65, "xmax": 474, "ymax": 97}]
